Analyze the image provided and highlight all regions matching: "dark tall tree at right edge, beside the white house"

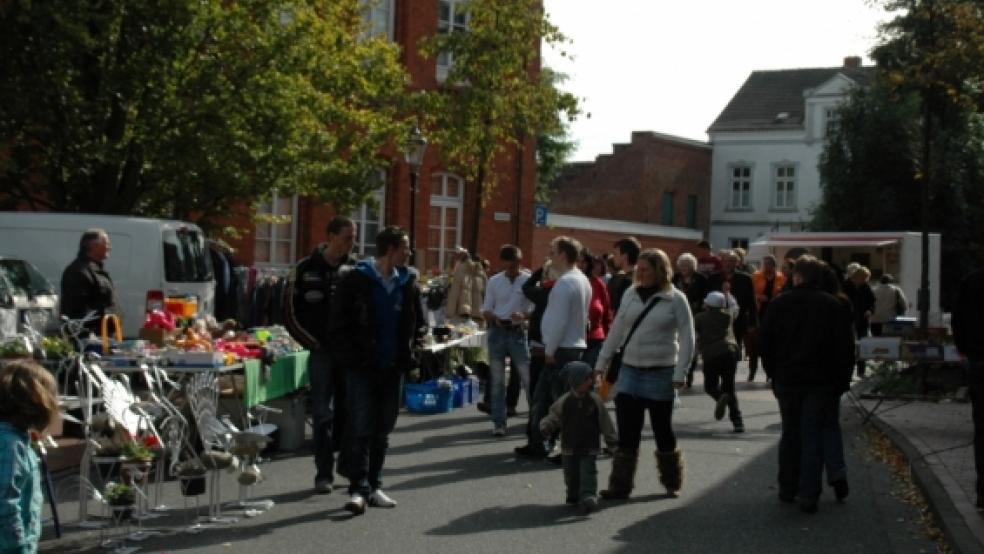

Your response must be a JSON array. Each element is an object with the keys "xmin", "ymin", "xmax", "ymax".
[{"xmin": 813, "ymin": 0, "xmax": 984, "ymax": 308}]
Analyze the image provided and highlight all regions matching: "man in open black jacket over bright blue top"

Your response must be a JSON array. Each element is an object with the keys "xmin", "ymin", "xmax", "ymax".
[{"xmin": 328, "ymin": 227, "xmax": 426, "ymax": 514}]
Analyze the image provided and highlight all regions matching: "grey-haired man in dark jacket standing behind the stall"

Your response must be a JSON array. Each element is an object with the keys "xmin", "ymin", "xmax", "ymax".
[{"xmin": 61, "ymin": 229, "xmax": 118, "ymax": 333}]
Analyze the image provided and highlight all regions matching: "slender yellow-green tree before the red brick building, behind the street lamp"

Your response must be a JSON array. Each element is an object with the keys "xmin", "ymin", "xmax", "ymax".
[{"xmin": 418, "ymin": 0, "xmax": 578, "ymax": 252}]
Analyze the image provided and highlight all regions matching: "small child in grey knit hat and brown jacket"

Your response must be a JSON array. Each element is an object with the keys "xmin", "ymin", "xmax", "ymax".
[{"xmin": 540, "ymin": 362, "xmax": 618, "ymax": 514}]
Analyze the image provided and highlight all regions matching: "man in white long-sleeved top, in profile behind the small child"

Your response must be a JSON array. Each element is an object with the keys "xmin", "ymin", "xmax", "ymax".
[{"xmin": 516, "ymin": 236, "xmax": 591, "ymax": 457}]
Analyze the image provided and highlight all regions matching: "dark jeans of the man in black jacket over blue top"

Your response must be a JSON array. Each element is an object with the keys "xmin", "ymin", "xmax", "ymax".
[{"xmin": 345, "ymin": 371, "xmax": 402, "ymax": 496}]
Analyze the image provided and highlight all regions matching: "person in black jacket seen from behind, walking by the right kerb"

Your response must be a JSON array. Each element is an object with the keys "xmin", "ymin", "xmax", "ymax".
[{"xmin": 759, "ymin": 256, "xmax": 854, "ymax": 513}]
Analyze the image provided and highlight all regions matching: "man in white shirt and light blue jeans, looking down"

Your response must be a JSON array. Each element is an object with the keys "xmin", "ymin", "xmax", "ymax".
[{"xmin": 482, "ymin": 244, "xmax": 533, "ymax": 437}]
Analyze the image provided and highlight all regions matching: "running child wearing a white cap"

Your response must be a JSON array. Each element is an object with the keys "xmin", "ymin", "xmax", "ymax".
[{"xmin": 694, "ymin": 292, "xmax": 745, "ymax": 433}]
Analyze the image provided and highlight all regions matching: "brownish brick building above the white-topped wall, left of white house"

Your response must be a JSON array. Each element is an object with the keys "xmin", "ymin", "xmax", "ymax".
[{"xmin": 550, "ymin": 132, "xmax": 711, "ymax": 234}]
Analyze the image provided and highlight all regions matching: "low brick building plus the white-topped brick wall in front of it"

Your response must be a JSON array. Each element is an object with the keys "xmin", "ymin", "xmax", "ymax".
[{"xmin": 531, "ymin": 131, "xmax": 711, "ymax": 260}]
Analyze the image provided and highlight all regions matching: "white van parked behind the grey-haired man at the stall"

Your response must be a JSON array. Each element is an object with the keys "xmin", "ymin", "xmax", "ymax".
[{"xmin": 0, "ymin": 212, "xmax": 215, "ymax": 337}]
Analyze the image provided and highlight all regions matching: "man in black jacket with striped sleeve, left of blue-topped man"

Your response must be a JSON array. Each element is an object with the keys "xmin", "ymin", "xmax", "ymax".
[{"xmin": 284, "ymin": 216, "xmax": 357, "ymax": 494}]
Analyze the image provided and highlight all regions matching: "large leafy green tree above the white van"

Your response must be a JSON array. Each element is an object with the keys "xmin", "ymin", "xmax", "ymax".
[{"xmin": 0, "ymin": 0, "xmax": 406, "ymax": 224}]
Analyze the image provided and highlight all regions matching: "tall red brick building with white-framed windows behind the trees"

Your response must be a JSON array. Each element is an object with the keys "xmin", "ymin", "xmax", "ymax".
[{"xmin": 227, "ymin": 0, "xmax": 536, "ymax": 271}]
